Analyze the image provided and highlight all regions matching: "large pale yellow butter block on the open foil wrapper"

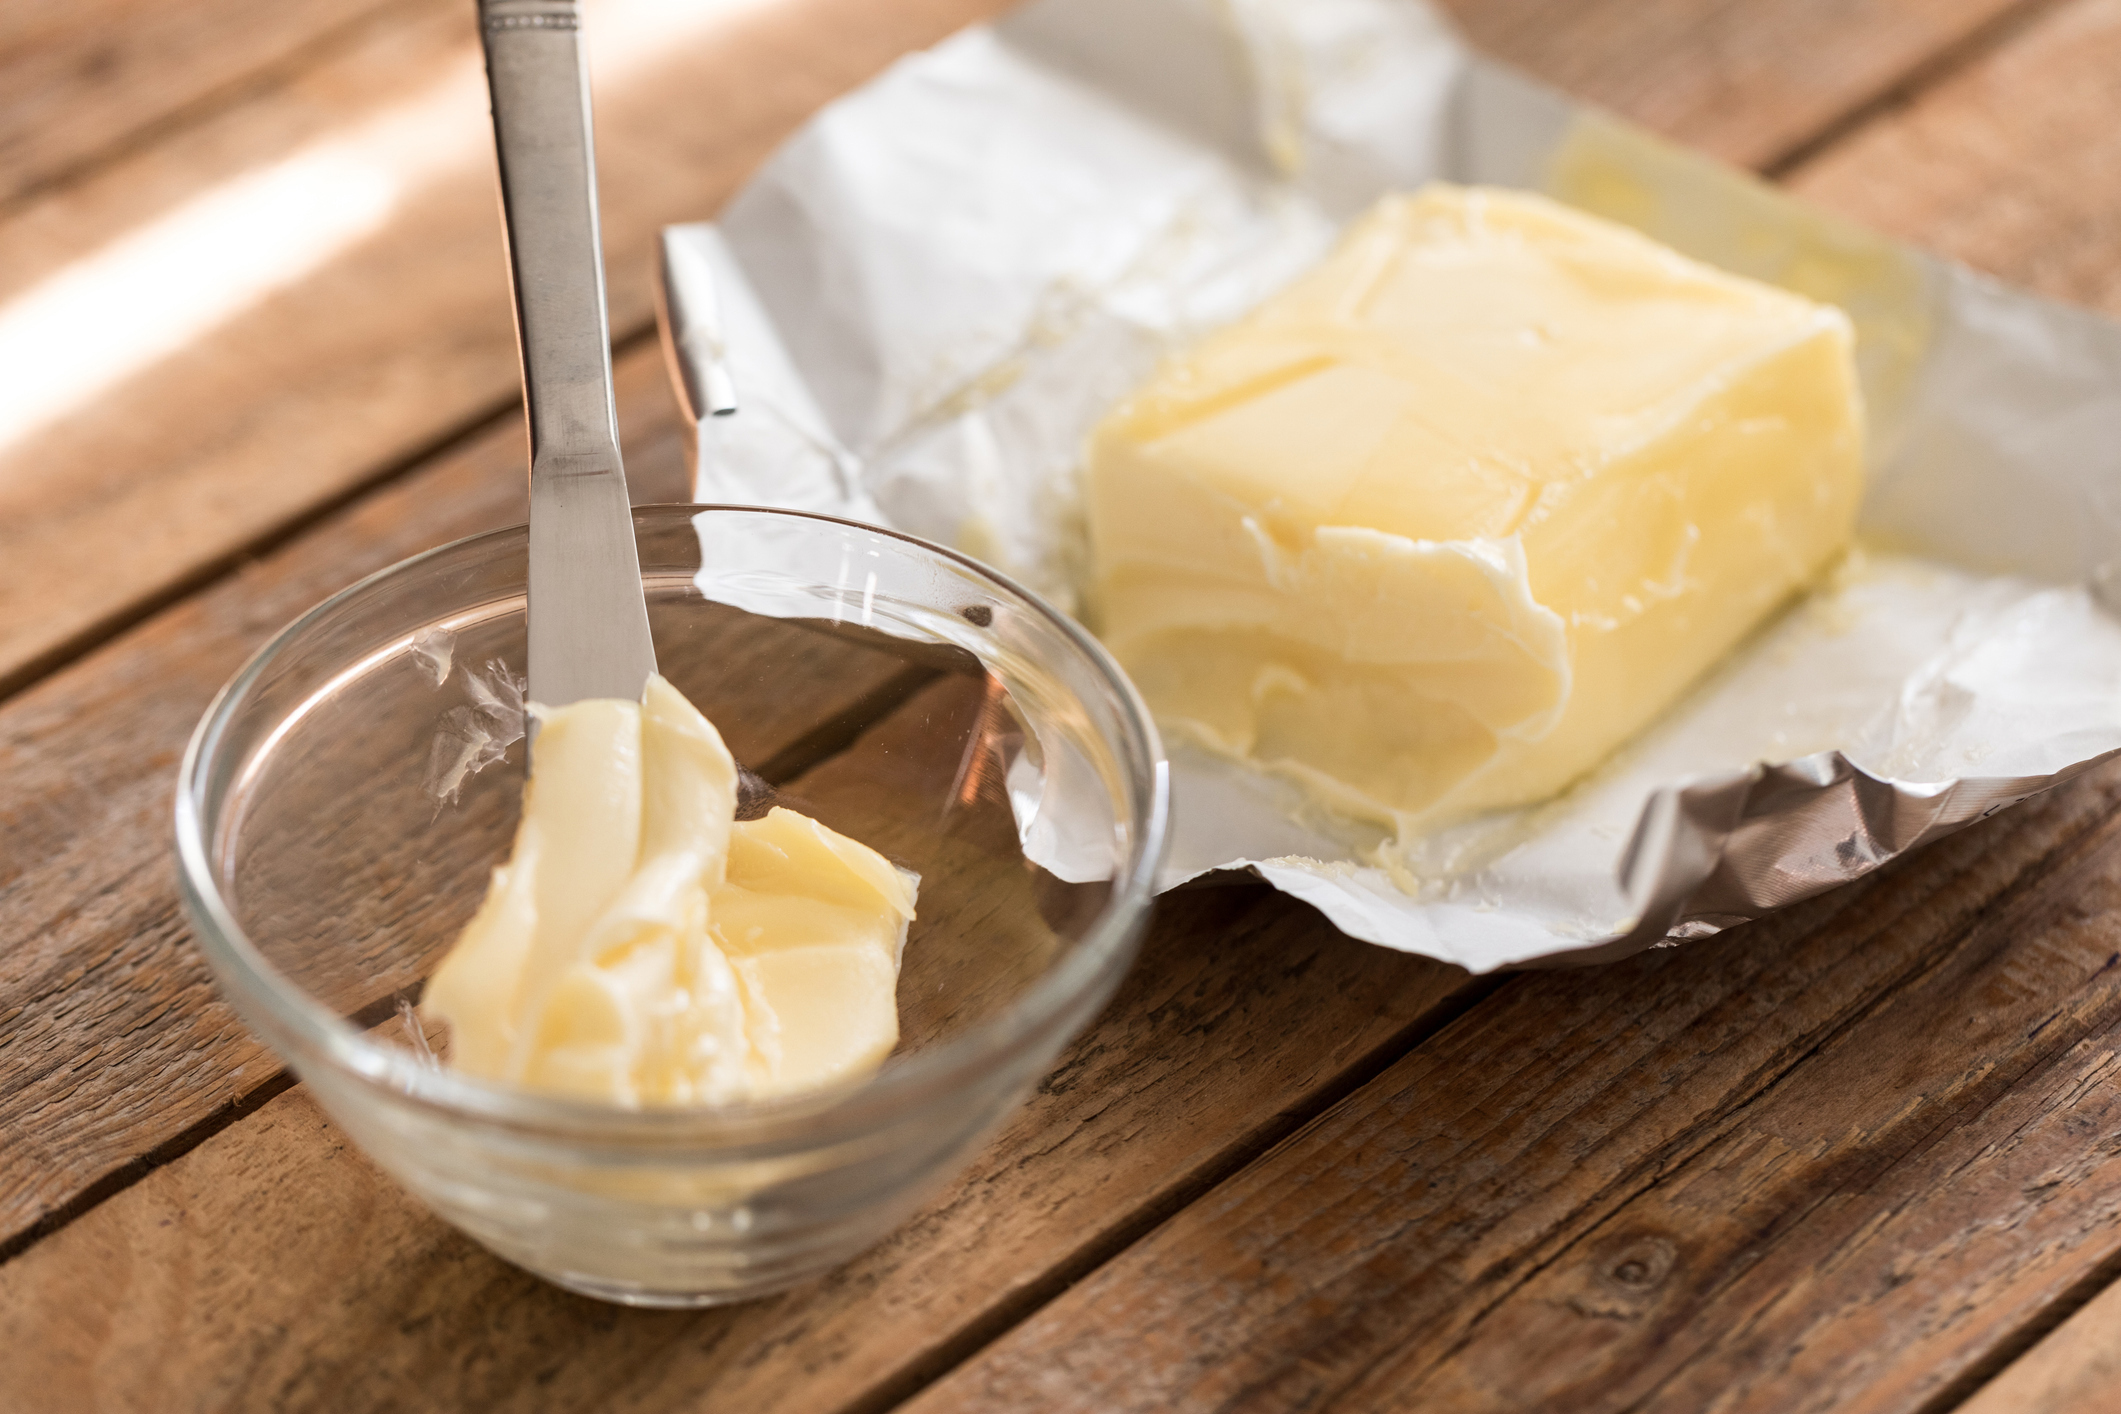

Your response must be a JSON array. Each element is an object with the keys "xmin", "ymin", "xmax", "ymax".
[{"xmin": 1086, "ymin": 187, "xmax": 1862, "ymax": 833}]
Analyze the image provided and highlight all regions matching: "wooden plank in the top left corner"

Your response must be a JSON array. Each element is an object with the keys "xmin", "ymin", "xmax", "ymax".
[{"xmin": 0, "ymin": 0, "xmax": 409, "ymax": 210}]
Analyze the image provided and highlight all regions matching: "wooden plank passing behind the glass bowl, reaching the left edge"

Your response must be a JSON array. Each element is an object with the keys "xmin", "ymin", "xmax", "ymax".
[{"xmin": 0, "ymin": 348, "xmax": 897, "ymax": 1251}]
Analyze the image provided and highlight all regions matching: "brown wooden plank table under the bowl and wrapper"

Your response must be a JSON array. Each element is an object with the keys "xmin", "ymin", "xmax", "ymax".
[{"xmin": 0, "ymin": 0, "xmax": 2121, "ymax": 1414}]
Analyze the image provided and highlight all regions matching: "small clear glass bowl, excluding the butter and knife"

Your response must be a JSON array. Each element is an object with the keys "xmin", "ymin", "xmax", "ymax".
[{"xmin": 176, "ymin": 507, "xmax": 1167, "ymax": 1306}]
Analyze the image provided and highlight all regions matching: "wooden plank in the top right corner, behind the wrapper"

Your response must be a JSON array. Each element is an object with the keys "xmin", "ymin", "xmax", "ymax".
[{"xmin": 1790, "ymin": 0, "xmax": 2121, "ymax": 314}]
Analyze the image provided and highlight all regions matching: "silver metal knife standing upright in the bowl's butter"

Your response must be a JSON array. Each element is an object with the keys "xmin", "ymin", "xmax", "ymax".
[{"xmin": 479, "ymin": 0, "xmax": 655, "ymax": 706}]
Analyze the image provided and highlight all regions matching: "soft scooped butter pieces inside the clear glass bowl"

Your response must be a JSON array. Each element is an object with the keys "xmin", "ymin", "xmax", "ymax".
[{"xmin": 420, "ymin": 676, "xmax": 918, "ymax": 1107}]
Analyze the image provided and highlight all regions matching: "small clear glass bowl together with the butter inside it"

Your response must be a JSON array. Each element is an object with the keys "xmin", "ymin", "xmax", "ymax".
[{"xmin": 176, "ymin": 507, "xmax": 1164, "ymax": 1306}]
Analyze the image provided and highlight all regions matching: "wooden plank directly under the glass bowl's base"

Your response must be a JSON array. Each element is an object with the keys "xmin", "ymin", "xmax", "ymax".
[{"xmin": 0, "ymin": 681, "xmax": 1463, "ymax": 1414}]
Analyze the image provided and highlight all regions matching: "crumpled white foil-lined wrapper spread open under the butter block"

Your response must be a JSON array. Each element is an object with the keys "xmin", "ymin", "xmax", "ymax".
[{"xmin": 664, "ymin": 0, "xmax": 2121, "ymax": 971}]
